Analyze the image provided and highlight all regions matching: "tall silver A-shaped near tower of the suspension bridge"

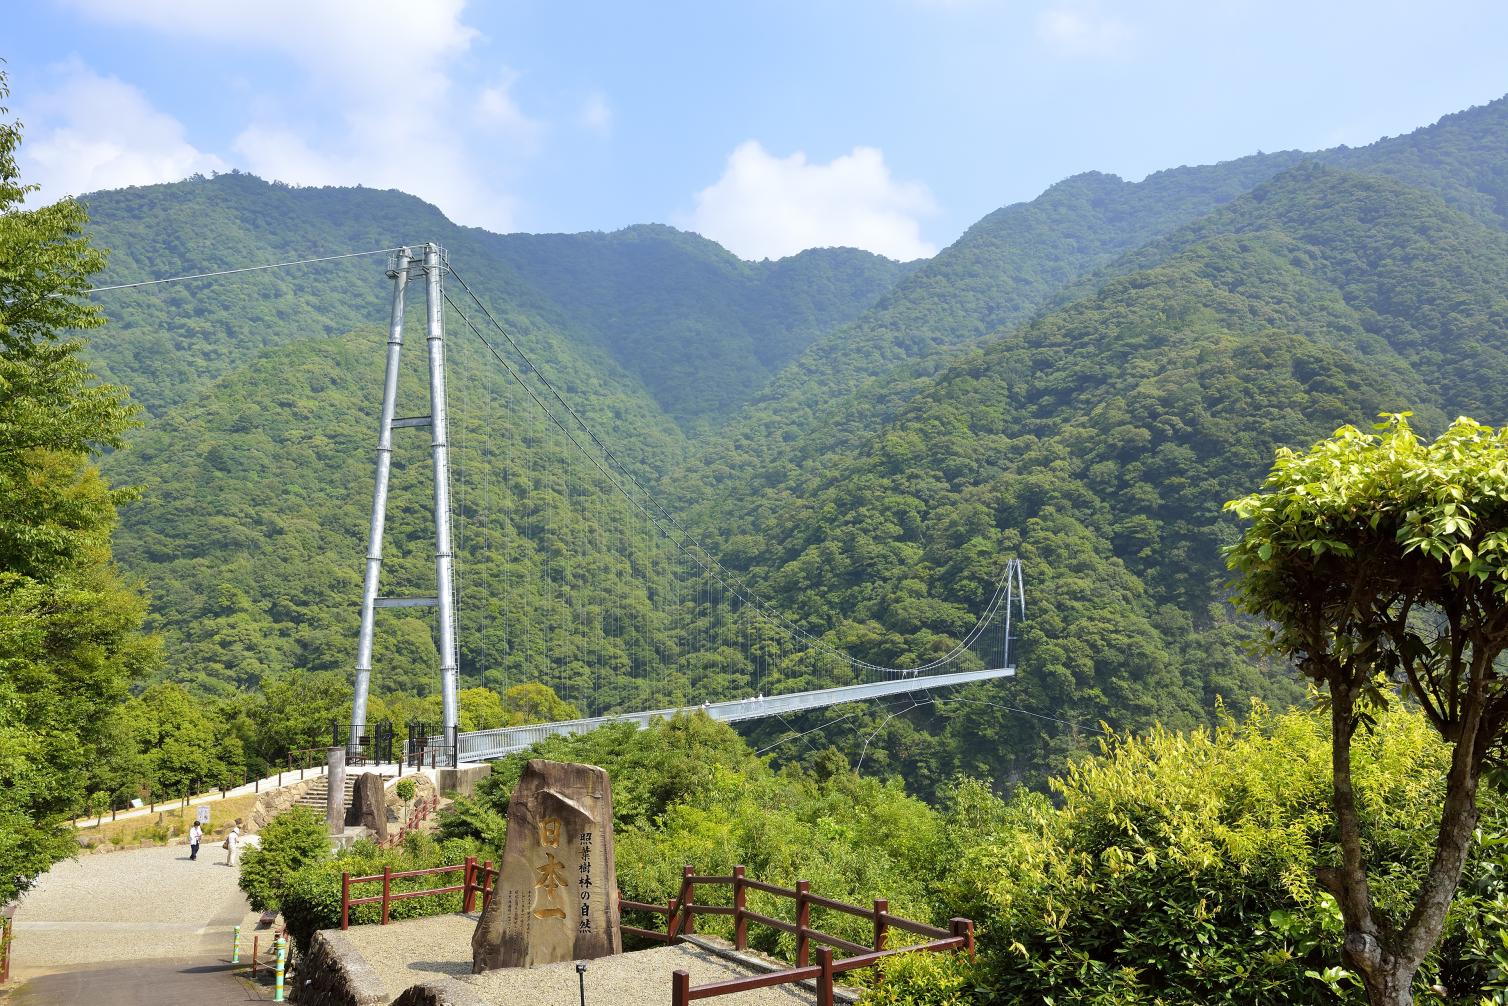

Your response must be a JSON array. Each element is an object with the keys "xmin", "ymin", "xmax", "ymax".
[{"xmin": 347, "ymin": 243, "xmax": 458, "ymax": 754}]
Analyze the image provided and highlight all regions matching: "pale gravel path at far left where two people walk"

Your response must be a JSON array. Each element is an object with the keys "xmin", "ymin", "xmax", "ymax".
[{"xmin": 11, "ymin": 845, "xmax": 256, "ymax": 977}]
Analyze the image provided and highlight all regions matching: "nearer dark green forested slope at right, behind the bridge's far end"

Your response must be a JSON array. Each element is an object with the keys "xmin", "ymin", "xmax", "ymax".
[{"xmin": 714, "ymin": 167, "xmax": 1508, "ymax": 780}]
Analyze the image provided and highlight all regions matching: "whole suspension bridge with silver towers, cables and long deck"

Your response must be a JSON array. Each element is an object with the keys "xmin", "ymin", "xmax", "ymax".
[{"xmin": 85, "ymin": 243, "xmax": 1025, "ymax": 763}]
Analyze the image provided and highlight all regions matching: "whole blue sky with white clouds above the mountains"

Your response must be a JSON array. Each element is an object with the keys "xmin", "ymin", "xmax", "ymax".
[{"xmin": 0, "ymin": 0, "xmax": 1508, "ymax": 259}]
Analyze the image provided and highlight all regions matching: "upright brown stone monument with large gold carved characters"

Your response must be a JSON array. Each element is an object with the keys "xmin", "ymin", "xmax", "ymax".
[{"xmin": 472, "ymin": 759, "xmax": 623, "ymax": 974}]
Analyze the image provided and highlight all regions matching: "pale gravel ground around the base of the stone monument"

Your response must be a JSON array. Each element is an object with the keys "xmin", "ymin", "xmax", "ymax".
[{"xmin": 345, "ymin": 916, "xmax": 814, "ymax": 1006}]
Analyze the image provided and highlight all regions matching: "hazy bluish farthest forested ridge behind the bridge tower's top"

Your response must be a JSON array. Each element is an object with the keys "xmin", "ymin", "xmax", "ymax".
[{"xmin": 87, "ymin": 173, "xmax": 908, "ymax": 440}]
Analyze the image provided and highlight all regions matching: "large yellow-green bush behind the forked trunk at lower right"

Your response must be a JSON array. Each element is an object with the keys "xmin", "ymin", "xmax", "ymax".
[{"xmin": 947, "ymin": 704, "xmax": 1500, "ymax": 1006}]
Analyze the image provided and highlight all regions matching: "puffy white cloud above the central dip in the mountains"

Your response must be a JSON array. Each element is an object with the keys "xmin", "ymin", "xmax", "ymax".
[{"xmin": 682, "ymin": 140, "xmax": 936, "ymax": 259}]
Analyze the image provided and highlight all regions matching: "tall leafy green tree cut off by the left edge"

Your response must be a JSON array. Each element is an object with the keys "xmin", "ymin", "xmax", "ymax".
[{"xmin": 0, "ymin": 74, "xmax": 155, "ymax": 903}]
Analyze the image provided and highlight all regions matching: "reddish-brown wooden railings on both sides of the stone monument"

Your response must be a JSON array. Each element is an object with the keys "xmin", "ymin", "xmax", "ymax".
[{"xmin": 341, "ymin": 857, "xmax": 974, "ymax": 1006}]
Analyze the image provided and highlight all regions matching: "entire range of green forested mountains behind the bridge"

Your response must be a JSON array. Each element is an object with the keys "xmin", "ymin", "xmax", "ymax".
[{"xmin": 76, "ymin": 90, "xmax": 1508, "ymax": 790}]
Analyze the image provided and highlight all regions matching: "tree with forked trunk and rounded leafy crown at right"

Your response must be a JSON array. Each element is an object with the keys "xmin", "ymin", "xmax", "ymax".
[{"xmin": 1226, "ymin": 413, "xmax": 1508, "ymax": 1004}]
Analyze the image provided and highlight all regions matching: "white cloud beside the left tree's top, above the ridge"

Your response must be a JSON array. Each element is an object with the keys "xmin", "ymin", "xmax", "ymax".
[{"xmin": 20, "ymin": 60, "xmax": 226, "ymax": 204}]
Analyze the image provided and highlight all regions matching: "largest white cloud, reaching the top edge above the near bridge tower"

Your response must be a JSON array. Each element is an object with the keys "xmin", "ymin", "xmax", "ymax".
[{"xmin": 58, "ymin": 0, "xmax": 527, "ymax": 231}]
